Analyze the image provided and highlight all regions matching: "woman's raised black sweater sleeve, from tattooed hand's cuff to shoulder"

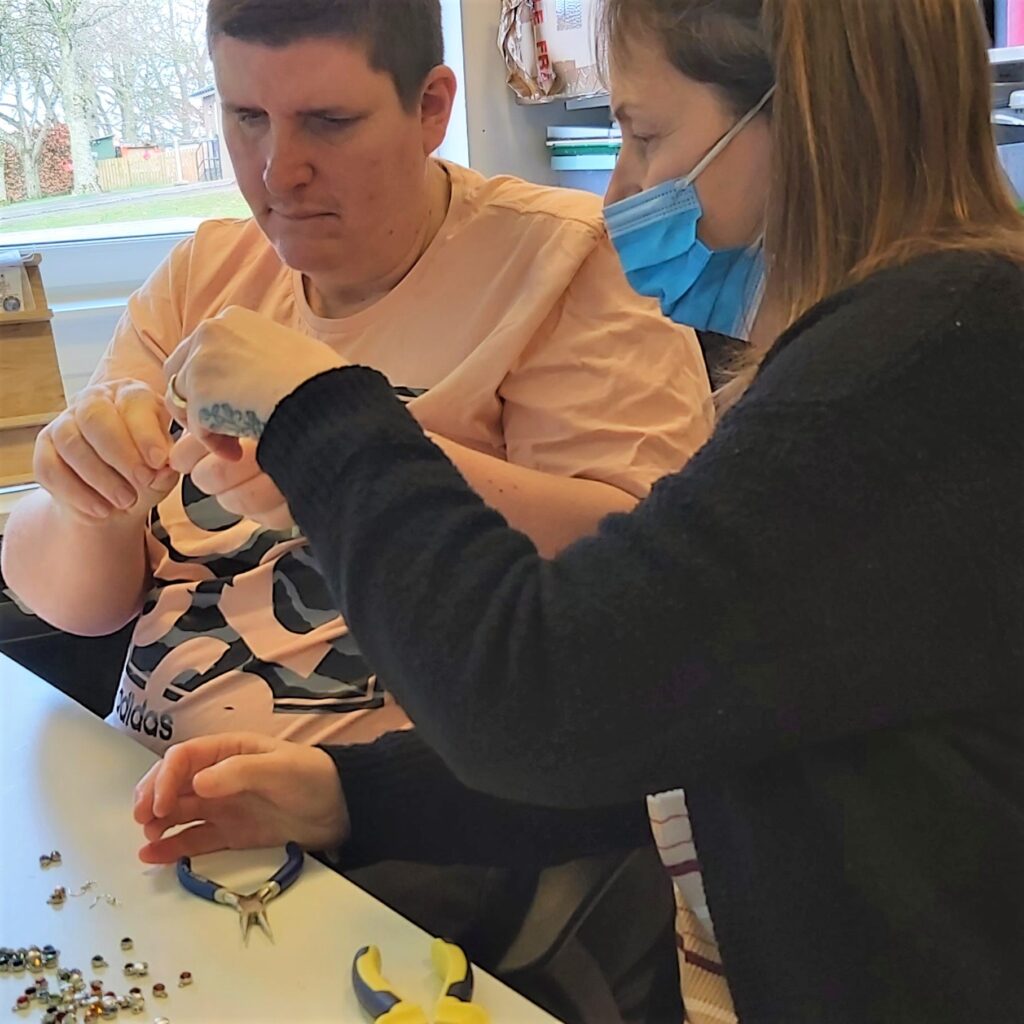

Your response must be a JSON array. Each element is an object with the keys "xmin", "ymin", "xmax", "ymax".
[{"xmin": 259, "ymin": 256, "xmax": 1024, "ymax": 807}]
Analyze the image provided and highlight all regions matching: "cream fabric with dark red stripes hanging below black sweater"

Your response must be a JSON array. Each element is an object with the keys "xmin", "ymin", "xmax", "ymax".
[{"xmin": 647, "ymin": 790, "xmax": 737, "ymax": 1024}]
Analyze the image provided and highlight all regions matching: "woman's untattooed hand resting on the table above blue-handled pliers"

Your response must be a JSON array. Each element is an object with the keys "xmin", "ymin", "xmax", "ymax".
[{"xmin": 133, "ymin": 732, "xmax": 349, "ymax": 864}]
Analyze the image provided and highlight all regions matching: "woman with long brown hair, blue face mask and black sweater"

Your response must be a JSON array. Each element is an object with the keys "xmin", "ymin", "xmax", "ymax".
[{"xmin": 135, "ymin": 0, "xmax": 1024, "ymax": 1024}]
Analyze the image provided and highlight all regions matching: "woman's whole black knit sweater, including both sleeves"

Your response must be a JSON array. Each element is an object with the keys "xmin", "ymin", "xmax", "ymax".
[{"xmin": 259, "ymin": 254, "xmax": 1024, "ymax": 1024}]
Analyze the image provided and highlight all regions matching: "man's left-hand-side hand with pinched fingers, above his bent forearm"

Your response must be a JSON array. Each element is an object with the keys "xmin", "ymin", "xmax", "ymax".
[{"xmin": 33, "ymin": 380, "xmax": 178, "ymax": 522}]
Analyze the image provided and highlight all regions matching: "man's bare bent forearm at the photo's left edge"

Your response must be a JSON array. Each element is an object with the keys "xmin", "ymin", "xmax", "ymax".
[{"xmin": 2, "ymin": 489, "xmax": 147, "ymax": 636}]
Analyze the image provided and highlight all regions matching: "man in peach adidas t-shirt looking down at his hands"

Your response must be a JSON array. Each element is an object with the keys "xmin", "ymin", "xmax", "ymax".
[{"xmin": 3, "ymin": 0, "xmax": 711, "ymax": 753}]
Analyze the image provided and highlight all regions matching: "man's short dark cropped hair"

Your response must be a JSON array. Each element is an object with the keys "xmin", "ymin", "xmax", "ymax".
[{"xmin": 206, "ymin": 0, "xmax": 444, "ymax": 110}]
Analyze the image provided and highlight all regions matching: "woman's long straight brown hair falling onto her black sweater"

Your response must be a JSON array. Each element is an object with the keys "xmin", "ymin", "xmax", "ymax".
[{"xmin": 764, "ymin": 0, "xmax": 1024, "ymax": 322}]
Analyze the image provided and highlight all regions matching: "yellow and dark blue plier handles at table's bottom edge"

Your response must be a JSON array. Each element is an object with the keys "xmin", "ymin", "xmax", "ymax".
[{"xmin": 352, "ymin": 939, "xmax": 490, "ymax": 1024}]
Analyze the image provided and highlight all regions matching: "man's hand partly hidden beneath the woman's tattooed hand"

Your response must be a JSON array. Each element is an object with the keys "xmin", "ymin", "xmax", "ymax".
[{"xmin": 171, "ymin": 431, "xmax": 295, "ymax": 530}]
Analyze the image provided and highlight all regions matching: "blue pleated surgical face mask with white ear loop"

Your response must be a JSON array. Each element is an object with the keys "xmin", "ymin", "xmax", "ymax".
[{"xmin": 604, "ymin": 86, "xmax": 775, "ymax": 339}]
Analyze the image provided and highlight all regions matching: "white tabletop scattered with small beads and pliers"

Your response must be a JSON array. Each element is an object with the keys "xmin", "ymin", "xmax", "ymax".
[{"xmin": 0, "ymin": 656, "xmax": 554, "ymax": 1024}]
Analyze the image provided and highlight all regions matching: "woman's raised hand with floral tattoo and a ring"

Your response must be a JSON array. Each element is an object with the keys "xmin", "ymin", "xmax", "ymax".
[{"xmin": 164, "ymin": 306, "xmax": 345, "ymax": 461}]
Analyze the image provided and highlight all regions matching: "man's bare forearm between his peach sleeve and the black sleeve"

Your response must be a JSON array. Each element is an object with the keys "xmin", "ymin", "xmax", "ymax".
[{"xmin": 428, "ymin": 434, "xmax": 637, "ymax": 557}]
